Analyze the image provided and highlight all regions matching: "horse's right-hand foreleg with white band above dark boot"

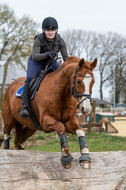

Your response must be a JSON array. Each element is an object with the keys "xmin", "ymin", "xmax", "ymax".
[{"xmin": 64, "ymin": 117, "xmax": 91, "ymax": 169}]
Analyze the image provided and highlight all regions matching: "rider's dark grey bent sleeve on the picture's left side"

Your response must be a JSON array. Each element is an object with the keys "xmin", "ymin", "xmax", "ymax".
[{"xmin": 32, "ymin": 38, "xmax": 48, "ymax": 61}]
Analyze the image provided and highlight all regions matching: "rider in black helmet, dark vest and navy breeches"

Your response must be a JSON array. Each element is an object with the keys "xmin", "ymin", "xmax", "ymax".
[{"xmin": 20, "ymin": 17, "xmax": 68, "ymax": 117}]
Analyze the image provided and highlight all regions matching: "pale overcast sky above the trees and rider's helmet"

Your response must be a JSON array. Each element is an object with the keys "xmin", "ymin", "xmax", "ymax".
[{"xmin": 0, "ymin": 0, "xmax": 126, "ymax": 35}]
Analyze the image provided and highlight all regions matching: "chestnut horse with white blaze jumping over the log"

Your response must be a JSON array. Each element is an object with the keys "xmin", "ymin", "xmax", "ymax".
[{"xmin": 2, "ymin": 56, "xmax": 97, "ymax": 168}]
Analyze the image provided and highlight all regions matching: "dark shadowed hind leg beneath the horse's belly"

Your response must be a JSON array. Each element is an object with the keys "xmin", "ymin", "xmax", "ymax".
[{"xmin": 14, "ymin": 123, "xmax": 36, "ymax": 150}]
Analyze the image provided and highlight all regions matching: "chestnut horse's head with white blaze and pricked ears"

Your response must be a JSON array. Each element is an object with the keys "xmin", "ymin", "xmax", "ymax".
[{"xmin": 72, "ymin": 59, "xmax": 97, "ymax": 113}]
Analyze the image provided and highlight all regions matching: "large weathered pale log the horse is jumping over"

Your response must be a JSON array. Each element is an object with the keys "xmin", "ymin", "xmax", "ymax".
[{"xmin": 0, "ymin": 150, "xmax": 126, "ymax": 190}]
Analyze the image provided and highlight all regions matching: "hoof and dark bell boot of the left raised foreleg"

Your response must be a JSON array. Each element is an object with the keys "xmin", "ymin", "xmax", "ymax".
[{"xmin": 61, "ymin": 154, "xmax": 73, "ymax": 169}]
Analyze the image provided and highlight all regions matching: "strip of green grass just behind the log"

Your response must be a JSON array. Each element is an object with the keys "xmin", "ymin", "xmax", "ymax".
[{"xmin": 27, "ymin": 132, "xmax": 126, "ymax": 152}]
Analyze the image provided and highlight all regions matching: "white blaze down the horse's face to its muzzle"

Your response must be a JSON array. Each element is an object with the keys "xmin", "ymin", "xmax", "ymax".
[{"xmin": 82, "ymin": 74, "xmax": 92, "ymax": 113}]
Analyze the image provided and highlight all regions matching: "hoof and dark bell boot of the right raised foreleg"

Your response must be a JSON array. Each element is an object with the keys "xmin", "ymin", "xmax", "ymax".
[{"xmin": 79, "ymin": 153, "xmax": 91, "ymax": 169}]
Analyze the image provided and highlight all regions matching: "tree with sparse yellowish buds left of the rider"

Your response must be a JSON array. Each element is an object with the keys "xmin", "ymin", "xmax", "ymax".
[{"xmin": 0, "ymin": 5, "xmax": 37, "ymax": 107}]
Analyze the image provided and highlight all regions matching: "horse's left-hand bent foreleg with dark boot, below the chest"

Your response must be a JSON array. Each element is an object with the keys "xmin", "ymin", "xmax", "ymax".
[{"xmin": 43, "ymin": 115, "xmax": 73, "ymax": 169}]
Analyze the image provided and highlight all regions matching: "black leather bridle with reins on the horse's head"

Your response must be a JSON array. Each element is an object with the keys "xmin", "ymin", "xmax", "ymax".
[{"xmin": 60, "ymin": 65, "xmax": 91, "ymax": 107}]
